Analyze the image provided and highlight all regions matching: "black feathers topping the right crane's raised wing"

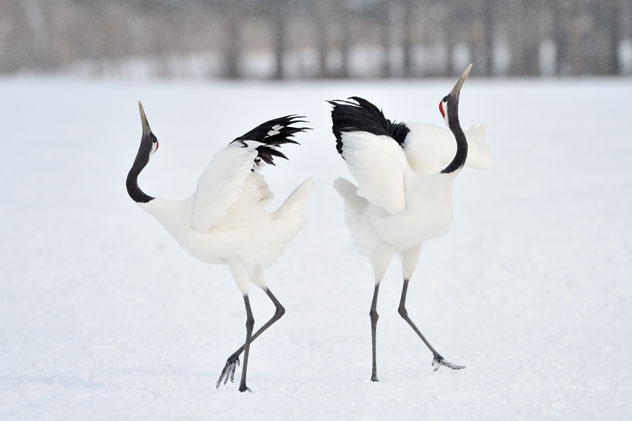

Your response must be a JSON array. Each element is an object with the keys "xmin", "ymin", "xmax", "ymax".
[{"xmin": 327, "ymin": 96, "xmax": 410, "ymax": 155}]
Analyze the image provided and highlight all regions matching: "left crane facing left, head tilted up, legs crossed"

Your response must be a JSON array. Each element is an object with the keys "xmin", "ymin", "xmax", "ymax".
[{"xmin": 126, "ymin": 102, "xmax": 312, "ymax": 392}]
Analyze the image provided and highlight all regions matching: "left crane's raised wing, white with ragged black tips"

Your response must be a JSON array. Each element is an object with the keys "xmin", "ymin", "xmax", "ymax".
[{"xmin": 193, "ymin": 116, "xmax": 307, "ymax": 232}]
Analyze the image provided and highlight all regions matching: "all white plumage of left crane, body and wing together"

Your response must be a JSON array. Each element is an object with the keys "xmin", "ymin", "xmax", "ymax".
[{"xmin": 138, "ymin": 142, "xmax": 313, "ymax": 294}]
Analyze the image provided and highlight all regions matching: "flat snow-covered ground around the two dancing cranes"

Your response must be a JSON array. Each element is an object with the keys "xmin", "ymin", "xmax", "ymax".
[{"xmin": 0, "ymin": 78, "xmax": 632, "ymax": 420}]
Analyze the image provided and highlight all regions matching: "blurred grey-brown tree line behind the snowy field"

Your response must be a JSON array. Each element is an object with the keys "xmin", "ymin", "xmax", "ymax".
[{"xmin": 0, "ymin": 0, "xmax": 632, "ymax": 79}]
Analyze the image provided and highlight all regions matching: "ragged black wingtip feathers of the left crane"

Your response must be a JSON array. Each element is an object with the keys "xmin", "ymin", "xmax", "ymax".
[{"xmin": 231, "ymin": 115, "xmax": 310, "ymax": 165}]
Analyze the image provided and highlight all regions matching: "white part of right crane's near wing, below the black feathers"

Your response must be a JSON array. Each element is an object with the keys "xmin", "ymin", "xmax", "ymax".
[{"xmin": 341, "ymin": 132, "xmax": 410, "ymax": 214}]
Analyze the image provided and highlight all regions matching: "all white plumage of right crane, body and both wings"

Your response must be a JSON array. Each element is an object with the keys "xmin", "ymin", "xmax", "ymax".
[{"xmin": 334, "ymin": 117, "xmax": 490, "ymax": 282}]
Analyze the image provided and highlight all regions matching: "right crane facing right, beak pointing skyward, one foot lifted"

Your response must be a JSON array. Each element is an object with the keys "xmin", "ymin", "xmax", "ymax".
[{"xmin": 330, "ymin": 64, "xmax": 490, "ymax": 381}]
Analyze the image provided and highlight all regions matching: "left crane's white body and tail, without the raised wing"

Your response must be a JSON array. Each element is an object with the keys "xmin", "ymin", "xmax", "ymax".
[{"xmin": 139, "ymin": 173, "xmax": 313, "ymax": 294}]
